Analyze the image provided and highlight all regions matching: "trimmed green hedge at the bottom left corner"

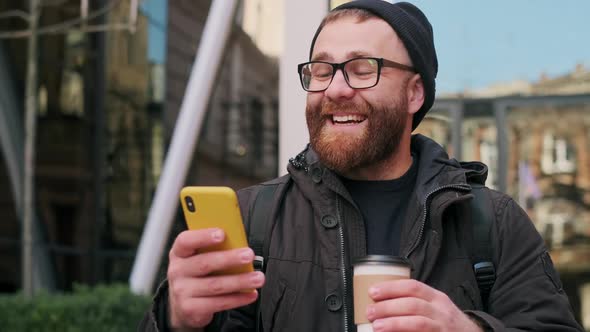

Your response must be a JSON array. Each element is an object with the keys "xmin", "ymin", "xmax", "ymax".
[{"xmin": 0, "ymin": 285, "xmax": 150, "ymax": 332}]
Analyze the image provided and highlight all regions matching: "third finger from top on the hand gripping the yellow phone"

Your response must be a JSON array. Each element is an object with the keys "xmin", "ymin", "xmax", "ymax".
[{"xmin": 170, "ymin": 272, "xmax": 264, "ymax": 297}]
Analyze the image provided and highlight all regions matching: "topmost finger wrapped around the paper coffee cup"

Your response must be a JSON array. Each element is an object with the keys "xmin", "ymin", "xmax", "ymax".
[{"xmin": 369, "ymin": 279, "xmax": 439, "ymax": 302}]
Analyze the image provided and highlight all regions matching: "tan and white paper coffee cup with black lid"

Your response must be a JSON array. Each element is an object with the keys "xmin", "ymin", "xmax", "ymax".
[{"xmin": 352, "ymin": 255, "xmax": 410, "ymax": 332}]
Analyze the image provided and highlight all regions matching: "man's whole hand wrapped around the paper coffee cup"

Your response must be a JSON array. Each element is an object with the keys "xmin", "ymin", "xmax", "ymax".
[{"xmin": 367, "ymin": 279, "xmax": 483, "ymax": 332}]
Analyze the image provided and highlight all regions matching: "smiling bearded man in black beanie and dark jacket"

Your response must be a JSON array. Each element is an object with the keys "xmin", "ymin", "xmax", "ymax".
[{"xmin": 141, "ymin": 0, "xmax": 582, "ymax": 332}]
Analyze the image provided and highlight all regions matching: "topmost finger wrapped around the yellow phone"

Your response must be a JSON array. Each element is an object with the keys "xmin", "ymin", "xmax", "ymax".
[{"xmin": 170, "ymin": 228, "xmax": 225, "ymax": 258}]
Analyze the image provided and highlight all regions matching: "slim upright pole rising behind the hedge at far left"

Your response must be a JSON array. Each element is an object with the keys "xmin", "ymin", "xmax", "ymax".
[{"xmin": 22, "ymin": 0, "xmax": 41, "ymax": 297}]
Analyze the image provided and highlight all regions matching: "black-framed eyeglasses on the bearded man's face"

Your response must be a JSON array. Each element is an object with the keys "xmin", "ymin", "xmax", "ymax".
[{"xmin": 297, "ymin": 57, "xmax": 416, "ymax": 92}]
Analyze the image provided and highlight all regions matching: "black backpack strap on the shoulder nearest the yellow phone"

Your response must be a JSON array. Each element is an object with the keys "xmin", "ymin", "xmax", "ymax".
[{"xmin": 248, "ymin": 183, "xmax": 279, "ymax": 332}]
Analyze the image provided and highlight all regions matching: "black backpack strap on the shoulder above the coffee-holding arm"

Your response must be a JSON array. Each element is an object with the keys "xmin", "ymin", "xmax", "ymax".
[{"xmin": 470, "ymin": 185, "xmax": 496, "ymax": 310}]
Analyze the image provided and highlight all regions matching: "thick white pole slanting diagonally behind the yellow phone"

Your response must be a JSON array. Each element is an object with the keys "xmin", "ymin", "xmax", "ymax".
[{"xmin": 129, "ymin": 0, "xmax": 237, "ymax": 294}]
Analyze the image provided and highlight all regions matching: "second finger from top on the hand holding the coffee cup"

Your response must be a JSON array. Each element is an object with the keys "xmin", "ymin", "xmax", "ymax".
[{"xmin": 367, "ymin": 297, "xmax": 435, "ymax": 321}]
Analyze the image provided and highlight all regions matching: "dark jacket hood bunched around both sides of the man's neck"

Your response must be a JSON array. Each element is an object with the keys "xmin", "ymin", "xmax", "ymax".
[{"xmin": 287, "ymin": 134, "xmax": 488, "ymax": 197}]
